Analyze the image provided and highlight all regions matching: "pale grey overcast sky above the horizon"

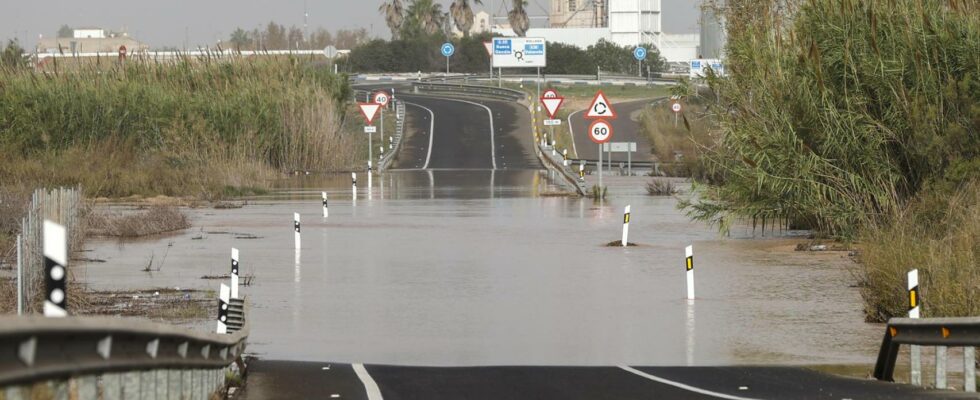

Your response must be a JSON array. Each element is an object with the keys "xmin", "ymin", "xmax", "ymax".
[{"xmin": 0, "ymin": 0, "xmax": 699, "ymax": 47}]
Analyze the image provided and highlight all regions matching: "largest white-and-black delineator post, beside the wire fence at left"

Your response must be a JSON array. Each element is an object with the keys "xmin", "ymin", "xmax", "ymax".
[{"xmin": 44, "ymin": 220, "xmax": 68, "ymax": 317}]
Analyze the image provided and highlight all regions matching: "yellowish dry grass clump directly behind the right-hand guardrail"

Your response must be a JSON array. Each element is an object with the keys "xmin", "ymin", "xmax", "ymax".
[{"xmin": 859, "ymin": 182, "xmax": 980, "ymax": 322}]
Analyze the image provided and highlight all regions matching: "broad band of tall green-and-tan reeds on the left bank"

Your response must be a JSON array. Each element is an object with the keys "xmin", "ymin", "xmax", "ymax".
[{"xmin": 0, "ymin": 57, "xmax": 356, "ymax": 199}]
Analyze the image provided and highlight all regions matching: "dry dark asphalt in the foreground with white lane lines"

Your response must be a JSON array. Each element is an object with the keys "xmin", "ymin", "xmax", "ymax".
[{"xmin": 235, "ymin": 360, "xmax": 977, "ymax": 400}]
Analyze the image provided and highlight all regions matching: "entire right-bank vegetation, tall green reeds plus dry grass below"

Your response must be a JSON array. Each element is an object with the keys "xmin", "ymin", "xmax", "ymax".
[{"xmin": 682, "ymin": 0, "xmax": 980, "ymax": 321}]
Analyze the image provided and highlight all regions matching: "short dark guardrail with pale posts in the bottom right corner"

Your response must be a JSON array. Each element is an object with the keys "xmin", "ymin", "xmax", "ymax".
[{"xmin": 874, "ymin": 317, "xmax": 980, "ymax": 392}]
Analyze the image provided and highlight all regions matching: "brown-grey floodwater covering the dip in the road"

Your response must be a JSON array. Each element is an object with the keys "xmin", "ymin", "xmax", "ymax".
[{"xmin": 83, "ymin": 170, "xmax": 883, "ymax": 366}]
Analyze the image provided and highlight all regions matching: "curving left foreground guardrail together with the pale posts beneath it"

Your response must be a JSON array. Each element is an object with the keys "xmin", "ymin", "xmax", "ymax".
[{"xmin": 0, "ymin": 299, "xmax": 249, "ymax": 399}]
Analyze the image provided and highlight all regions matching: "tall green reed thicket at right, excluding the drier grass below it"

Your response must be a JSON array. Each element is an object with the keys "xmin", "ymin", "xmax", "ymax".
[{"xmin": 685, "ymin": 0, "xmax": 980, "ymax": 238}]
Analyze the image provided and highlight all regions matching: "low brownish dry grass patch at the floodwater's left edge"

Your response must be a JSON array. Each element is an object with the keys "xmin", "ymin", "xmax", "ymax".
[{"xmin": 88, "ymin": 206, "xmax": 191, "ymax": 238}]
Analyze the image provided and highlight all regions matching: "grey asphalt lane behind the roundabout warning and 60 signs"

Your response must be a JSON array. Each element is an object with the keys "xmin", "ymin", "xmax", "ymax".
[{"xmin": 568, "ymin": 99, "xmax": 653, "ymax": 163}]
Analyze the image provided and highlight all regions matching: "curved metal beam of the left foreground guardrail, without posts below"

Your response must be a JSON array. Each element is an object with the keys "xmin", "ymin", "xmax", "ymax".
[{"xmin": 0, "ymin": 300, "xmax": 249, "ymax": 390}]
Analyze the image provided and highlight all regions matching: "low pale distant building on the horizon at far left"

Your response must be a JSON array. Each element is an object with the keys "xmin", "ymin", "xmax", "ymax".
[{"xmin": 37, "ymin": 28, "xmax": 149, "ymax": 54}]
